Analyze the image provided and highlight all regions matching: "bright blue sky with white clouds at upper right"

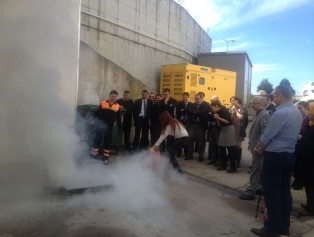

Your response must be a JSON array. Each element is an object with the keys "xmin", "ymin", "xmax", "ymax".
[{"xmin": 181, "ymin": 0, "xmax": 314, "ymax": 95}]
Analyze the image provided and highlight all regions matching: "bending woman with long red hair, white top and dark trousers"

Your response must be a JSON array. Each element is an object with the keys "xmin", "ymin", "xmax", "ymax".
[{"xmin": 151, "ymin": 111, "xmax": 188, "ymax": 173}]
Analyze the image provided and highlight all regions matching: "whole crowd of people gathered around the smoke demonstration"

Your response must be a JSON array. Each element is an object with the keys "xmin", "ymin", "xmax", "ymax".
[{"xmin": 91, "ymin": 86, "xmax": 314, "ymax": 236}]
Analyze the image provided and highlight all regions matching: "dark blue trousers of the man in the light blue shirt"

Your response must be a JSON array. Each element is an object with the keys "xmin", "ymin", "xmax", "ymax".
[{"xmin": 262, "ymin": 152, "xmax": 295, "ymax": 234}]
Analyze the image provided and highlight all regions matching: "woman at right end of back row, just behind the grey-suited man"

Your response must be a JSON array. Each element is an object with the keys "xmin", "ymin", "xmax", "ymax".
[{"xmin": 230, "ymin": 96, "xmax": 249, "ymax": 168}]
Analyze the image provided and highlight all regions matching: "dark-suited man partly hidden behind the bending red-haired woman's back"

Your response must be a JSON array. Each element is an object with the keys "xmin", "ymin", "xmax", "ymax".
[{"xmin": 176, "ymin": 92, "xmax": 192, "ymax": 157}]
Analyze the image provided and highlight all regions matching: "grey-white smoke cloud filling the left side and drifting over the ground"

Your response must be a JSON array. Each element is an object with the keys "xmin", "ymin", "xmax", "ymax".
[{"xmin": 0, "ymin": 0, "xmax": 181, "ymax": 217}]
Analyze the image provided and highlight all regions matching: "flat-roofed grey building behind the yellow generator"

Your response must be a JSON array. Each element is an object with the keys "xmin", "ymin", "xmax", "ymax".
[{"xmin": 198, "ymin": 52, "xmax": 252, "ymax": 105}]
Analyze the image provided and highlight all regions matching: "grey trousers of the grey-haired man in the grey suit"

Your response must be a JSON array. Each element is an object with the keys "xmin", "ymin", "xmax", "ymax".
[{"xmin": 246, "ymin": 150, "xmax": 264, "ymax": 197}]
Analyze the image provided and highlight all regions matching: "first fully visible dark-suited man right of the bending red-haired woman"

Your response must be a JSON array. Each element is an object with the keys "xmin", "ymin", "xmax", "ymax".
[{"xmin": 184, "ymin": 94, "xmax": 209, "ymax": 162}]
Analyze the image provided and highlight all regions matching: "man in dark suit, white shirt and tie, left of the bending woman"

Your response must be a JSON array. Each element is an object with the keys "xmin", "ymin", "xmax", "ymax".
[{"xmin": 133, "ymin": 90, "xmax": 153, "ymax": 151}]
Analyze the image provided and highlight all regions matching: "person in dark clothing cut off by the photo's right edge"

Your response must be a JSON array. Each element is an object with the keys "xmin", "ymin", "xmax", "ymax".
[{"xmin": 299, "ymin": 102, "xmax": 314, "ymax": 216}]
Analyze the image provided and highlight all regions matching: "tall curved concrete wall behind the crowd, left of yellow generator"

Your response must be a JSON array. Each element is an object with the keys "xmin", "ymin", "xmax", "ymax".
[{"xmin": 78, "ymin": 0, "xmax": 211, "ymax": 103}]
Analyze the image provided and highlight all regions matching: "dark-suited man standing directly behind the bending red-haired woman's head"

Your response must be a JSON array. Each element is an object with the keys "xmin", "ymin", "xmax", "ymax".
[{"xmin": 159, "ymin": 88, "xmax": 177, "ymax": 151}]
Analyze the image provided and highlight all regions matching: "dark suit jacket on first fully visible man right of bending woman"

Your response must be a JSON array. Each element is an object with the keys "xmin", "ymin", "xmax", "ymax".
[{"xmin": 187, "ymin": 103, "xmax": 209, "ymax": 130}]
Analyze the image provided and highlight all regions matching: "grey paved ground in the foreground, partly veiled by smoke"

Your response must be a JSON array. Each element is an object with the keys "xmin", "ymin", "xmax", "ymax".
[{"xmin": 0, "ymin": 136, "xmax": 314, "ymax": 237}]
